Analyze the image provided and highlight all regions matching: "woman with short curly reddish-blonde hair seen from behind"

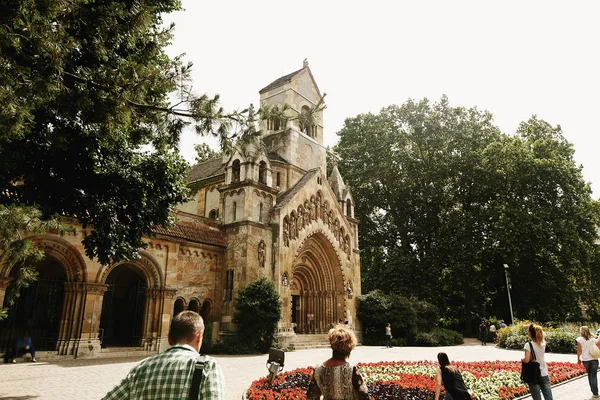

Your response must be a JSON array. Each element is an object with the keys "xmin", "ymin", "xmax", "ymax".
[{"xmin": 306, "ymin": 325, "xmax": 369, "ymax": 400}]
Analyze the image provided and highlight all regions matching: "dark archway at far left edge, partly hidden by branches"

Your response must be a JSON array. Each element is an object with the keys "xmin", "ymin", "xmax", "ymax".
[{"xmin": 0, "ymin": 256, "xmax": 67, "ymax": 351}]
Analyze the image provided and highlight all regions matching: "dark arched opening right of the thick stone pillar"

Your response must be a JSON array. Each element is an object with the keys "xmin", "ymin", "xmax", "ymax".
[{"xmin": 100, "ymin": 264, "xmax": 147, "ymax": 347}]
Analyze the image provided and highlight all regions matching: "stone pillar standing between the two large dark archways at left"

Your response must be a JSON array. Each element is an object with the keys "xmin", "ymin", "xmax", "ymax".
[{"xmin": 74, "ymin": 282, "xmax": 108, "ymax": 358}]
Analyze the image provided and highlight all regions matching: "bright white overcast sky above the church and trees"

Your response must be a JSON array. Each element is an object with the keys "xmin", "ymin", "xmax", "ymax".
[{"xmin": 165, "ymin": 0, "xmax": 600, "ymax": 198}]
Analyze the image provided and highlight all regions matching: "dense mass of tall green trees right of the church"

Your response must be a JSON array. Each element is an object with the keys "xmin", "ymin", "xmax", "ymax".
[{"xmin": 335, "ymin": 97, "xmax": 598, "ymax": 324}]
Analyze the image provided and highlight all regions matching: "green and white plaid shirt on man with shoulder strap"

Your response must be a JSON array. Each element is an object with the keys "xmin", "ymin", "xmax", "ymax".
[{"xmin": 104, "ymin": 344, "xmax": 225, "ymax": 400}]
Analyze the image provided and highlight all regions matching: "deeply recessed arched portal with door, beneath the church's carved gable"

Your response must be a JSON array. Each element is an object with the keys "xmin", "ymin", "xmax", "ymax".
[{"xmin": 290, "ymin": 234, "xmax": 346, "ymax": 334}]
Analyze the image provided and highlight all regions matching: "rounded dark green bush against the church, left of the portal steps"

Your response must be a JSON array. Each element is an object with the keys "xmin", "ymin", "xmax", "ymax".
[{"xmin": 233, "ymin": 277, "xmax": 281, "ymax": 353}]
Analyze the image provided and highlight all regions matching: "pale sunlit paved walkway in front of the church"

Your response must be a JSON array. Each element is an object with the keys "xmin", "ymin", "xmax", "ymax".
[{"xmin": 0, "ymin": 340, "xmax": 591, "ymax": 400}]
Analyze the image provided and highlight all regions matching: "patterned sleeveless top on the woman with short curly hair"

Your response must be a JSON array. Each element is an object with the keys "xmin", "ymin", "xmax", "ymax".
[{"xmin": 306, "ymin": 361, "xmax": 369, "ymax": 400}]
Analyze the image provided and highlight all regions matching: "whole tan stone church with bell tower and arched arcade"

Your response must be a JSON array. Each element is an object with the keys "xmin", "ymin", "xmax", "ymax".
[{"xmin": 0, "ymin": 61, "xmax": 360, "ymax": 358}]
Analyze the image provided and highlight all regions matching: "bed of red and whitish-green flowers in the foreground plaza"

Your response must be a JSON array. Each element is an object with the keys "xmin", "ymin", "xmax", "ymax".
[{"xmin": 246, "ymin": 361, "xmax": 585, "ymax": 400}]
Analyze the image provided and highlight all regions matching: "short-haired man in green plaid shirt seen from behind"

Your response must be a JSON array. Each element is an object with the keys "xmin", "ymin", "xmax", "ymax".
[{"xmin": 104, "ymin": 311, "xmax": 225, "ymax": 400}]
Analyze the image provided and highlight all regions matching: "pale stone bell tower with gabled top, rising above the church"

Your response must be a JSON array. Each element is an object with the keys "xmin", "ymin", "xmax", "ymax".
[{"xmin": 259, "ymin": 60, "xmax": 326, "ymax": 189}]
